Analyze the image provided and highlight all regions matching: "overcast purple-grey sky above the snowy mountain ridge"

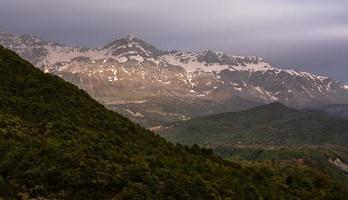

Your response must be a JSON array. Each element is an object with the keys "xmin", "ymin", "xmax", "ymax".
[{"xmin": 0, "ymin": 0, "xmax": 348, "ymax": 82}]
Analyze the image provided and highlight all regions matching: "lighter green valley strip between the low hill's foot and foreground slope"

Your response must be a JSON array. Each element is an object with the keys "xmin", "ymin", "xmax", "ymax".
[{"xmin": 211, "ymin": 145, "xmax": 348, "ymax": 178}]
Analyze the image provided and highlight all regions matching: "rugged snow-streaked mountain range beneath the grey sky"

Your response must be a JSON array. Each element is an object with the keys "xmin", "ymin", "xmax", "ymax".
[{"xmin": 0, "ymin": 33, "xmax": 348, "ymax": 127}]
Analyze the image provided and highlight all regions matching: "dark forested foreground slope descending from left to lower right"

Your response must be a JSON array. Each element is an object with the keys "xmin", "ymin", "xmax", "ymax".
[{"xmin": 0, "ymin": 47, "xmax": 348, "ymax": 200}]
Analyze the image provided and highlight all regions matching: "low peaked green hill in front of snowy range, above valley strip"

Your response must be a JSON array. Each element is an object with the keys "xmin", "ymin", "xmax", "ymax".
[{"xmin": 162, "ymin": 102, "xmax": 348, "ymax": 146}]
